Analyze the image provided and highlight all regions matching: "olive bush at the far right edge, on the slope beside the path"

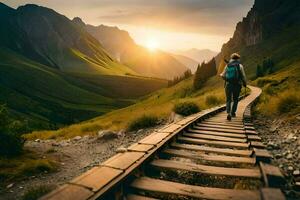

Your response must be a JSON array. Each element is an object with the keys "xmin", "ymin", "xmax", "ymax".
[{"xmin": 277, "ymin": 94, "xmax": 300, "ymax": 114}]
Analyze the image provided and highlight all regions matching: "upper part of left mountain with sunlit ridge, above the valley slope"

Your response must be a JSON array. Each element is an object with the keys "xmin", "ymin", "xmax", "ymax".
[{"xmin": 0, "ymin": 4, "xmax": 134, "ymax": 75}]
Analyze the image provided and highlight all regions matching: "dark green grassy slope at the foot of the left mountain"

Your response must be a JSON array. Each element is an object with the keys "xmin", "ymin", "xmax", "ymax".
[{"xmin": 0, "ymin": 49, "xmax": 166, "ymax": 129}]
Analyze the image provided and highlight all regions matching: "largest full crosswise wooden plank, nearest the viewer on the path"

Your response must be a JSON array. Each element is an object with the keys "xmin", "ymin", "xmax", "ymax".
[{"xmin": 131, "ymin": 177, "xmax": 260, "ymax": 200}]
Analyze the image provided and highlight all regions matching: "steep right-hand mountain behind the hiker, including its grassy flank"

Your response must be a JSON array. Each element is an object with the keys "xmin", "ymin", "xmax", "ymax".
[{"xmin": 217, "ymin": 0, "xmax": 300, "ymax": 79}]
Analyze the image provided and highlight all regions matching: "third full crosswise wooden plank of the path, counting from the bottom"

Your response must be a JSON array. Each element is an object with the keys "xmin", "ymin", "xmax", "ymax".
[{"xmin": 171, "ymin": 143, "xmax": 253, "ymax": 157}]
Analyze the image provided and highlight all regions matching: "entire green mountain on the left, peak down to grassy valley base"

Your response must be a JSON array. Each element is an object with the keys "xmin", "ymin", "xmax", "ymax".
[{"xmin": 0, "ymin": 3, "xmax": 167, "ymax": 130}]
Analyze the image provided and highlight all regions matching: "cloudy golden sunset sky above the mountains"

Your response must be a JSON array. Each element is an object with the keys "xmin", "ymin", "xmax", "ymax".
[{"xmin": 1, "ymin": 0, "xmax": 254, "ymax": 51}]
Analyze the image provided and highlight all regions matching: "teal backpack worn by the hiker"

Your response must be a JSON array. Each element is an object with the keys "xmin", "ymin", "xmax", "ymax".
[{"xmin": 225, "ymin": 61, "xmax": 241, "ymax": 84}]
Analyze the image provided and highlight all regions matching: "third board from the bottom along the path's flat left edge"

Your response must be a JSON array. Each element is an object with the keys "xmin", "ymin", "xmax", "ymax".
[{"xmin": 102, "ymin": 152, "xmax": 145, "ymax": 170}]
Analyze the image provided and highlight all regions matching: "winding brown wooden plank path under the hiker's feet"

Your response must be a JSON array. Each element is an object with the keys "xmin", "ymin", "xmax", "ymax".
[{"xmin": 42, "ymin": 87, "xmax": 285, "ymax": 200}]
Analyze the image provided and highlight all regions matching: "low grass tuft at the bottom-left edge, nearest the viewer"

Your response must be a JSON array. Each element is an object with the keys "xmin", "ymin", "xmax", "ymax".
[{"xmin": 22, "ymin": 185, "xmax": 55, "ymax": 200}]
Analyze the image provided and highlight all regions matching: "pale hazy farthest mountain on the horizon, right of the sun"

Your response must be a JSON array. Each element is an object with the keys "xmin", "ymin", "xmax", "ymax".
[{"xmin": 178, "ymin": 48, "xmax": 218, "ymax": 63}]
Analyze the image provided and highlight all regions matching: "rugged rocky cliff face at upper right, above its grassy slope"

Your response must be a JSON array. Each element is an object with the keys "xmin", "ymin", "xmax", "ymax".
[{"xmin": 216, "ymin": 0, "xmax": 300, "ymax": 72}]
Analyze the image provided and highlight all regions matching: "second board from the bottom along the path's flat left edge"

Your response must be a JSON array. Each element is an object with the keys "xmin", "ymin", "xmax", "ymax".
[{"xmin": 71, "ymin": 167, "xmax": 123, "ymax": 192}]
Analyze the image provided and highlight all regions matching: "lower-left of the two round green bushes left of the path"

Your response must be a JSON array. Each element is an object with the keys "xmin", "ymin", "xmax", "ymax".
[{"xmin": 128, "ymin": 115, "xmax": 158, "ymax": 131}]
